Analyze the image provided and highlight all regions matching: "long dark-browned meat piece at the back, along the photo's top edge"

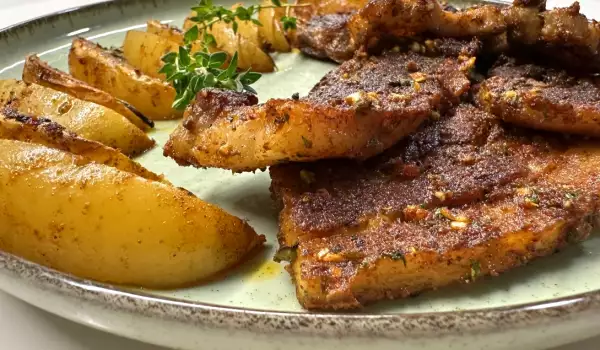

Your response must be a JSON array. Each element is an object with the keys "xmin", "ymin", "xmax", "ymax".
[{"xmin": 296, "ymin": 0, "xmax": 600, "ymax": 72}]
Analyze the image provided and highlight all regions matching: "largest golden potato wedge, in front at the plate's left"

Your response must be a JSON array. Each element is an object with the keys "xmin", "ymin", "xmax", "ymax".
[{"xmin": 0, "ymin": 140, "xmax": 264, "ymax": 288}]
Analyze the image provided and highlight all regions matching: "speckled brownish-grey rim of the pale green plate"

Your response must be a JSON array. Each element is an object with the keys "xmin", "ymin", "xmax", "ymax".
[{"xmin": 0, "ymin": 0, "xmax": 600, "ymax": 339}]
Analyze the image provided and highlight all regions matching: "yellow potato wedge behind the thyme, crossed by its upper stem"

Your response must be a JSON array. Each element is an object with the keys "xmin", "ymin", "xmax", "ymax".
[{"xmin": 184, "ymin": 8, "xmax": 275, "ymax": 73}]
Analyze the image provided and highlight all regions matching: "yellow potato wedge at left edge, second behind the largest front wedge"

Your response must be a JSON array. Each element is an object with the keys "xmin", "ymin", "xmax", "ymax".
[{"xmin": 0, "ymin": 80, "xmax": 154, "ymax": 156}]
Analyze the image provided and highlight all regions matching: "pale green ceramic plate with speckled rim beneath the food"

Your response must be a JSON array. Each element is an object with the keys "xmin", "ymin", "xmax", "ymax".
[{"xmin": 0, "ymin": 0, "xmax": 600, "ymax": 350}]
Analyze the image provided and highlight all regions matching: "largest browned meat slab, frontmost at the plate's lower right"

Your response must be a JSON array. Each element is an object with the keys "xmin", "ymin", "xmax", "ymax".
[{"xmin": 271, "ymin": 105, "xmax": 600, "ymax": 309}]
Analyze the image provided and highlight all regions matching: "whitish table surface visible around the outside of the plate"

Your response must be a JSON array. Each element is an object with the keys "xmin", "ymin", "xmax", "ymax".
[{"xmin": 0, "ymin": 0, "xmax": 600, "ymax": 350}]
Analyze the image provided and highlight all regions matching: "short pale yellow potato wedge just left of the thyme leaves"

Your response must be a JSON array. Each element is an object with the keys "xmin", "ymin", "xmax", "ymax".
[{"xmin": 123, "ymin": 30, "xmax": 179, "ymax": 80}]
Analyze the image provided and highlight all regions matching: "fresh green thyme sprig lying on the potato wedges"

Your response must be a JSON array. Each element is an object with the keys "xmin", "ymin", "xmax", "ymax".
[{"xmin": 159, "ymin": 0, "xmax": 303, "ymax": 110}]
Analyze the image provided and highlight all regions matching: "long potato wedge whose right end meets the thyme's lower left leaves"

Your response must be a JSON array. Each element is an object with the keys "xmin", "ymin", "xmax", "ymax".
[{"xmin": 69, "ymin": 38, "xmax": 182, "ymax": 120}]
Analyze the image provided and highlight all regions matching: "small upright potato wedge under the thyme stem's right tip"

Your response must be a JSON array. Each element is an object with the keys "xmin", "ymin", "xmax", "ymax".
[{"xmin": 258, "ymin": 0, "xmax": 291, "ymax": 52}]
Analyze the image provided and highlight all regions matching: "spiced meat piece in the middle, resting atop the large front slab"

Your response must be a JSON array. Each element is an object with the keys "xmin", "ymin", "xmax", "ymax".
[{"xmin": 165, "ymin": 44, "xmax": 475, "ymax": 171}]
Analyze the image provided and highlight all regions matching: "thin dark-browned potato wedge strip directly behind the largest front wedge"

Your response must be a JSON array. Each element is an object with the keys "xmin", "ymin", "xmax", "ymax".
[{"xmin": 0, "ymin": 108, "xmax": 166, "ymax": 182}]
